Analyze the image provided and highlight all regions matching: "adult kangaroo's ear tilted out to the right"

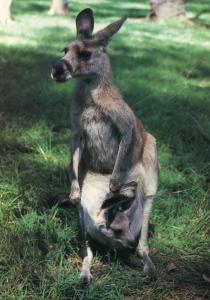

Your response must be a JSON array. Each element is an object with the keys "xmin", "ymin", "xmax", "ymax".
[{"xmin": 93, "ymin": 16, "xmax": 127, "ymax": 46}]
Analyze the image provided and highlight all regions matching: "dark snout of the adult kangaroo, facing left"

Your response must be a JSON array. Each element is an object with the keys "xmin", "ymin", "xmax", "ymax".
[{"xmin": 51, "ymin": 59, "xmax": 72, "ymax": 82}]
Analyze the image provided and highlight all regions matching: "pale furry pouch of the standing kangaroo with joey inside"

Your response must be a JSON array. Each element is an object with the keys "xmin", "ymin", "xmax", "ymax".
[{"xmin": 81, "ymin": 173, "xmax": 144, "ymax": 249}]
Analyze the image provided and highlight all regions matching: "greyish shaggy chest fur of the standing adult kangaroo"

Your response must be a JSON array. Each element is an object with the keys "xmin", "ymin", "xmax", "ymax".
[{"xmin": 80, "ymin": 105, "xmax": 119, "ymax": 173}]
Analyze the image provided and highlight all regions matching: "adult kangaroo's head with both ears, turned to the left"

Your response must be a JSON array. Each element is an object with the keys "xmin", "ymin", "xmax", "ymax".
[{"xmin": 51, "ymin": 8, "xmax": 126, "ymax": 82}]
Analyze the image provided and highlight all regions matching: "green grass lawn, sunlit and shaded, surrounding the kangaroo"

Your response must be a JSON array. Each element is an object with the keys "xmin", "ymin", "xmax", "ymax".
[{"xmin": 0, "ymin": 0, "xmax": 210, "ymax": 300}]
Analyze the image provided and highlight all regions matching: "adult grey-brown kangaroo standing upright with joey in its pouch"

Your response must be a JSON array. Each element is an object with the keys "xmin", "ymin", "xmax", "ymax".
[{"xmin": 51, "ymin": 8, "xmax": 158, "ymax": 283}]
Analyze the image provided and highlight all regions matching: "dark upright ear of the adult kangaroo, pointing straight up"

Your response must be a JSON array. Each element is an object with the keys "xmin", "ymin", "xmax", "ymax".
[{"xmin": 76, "ymin": 8, "xmax": 94, "ymax": 38}]
